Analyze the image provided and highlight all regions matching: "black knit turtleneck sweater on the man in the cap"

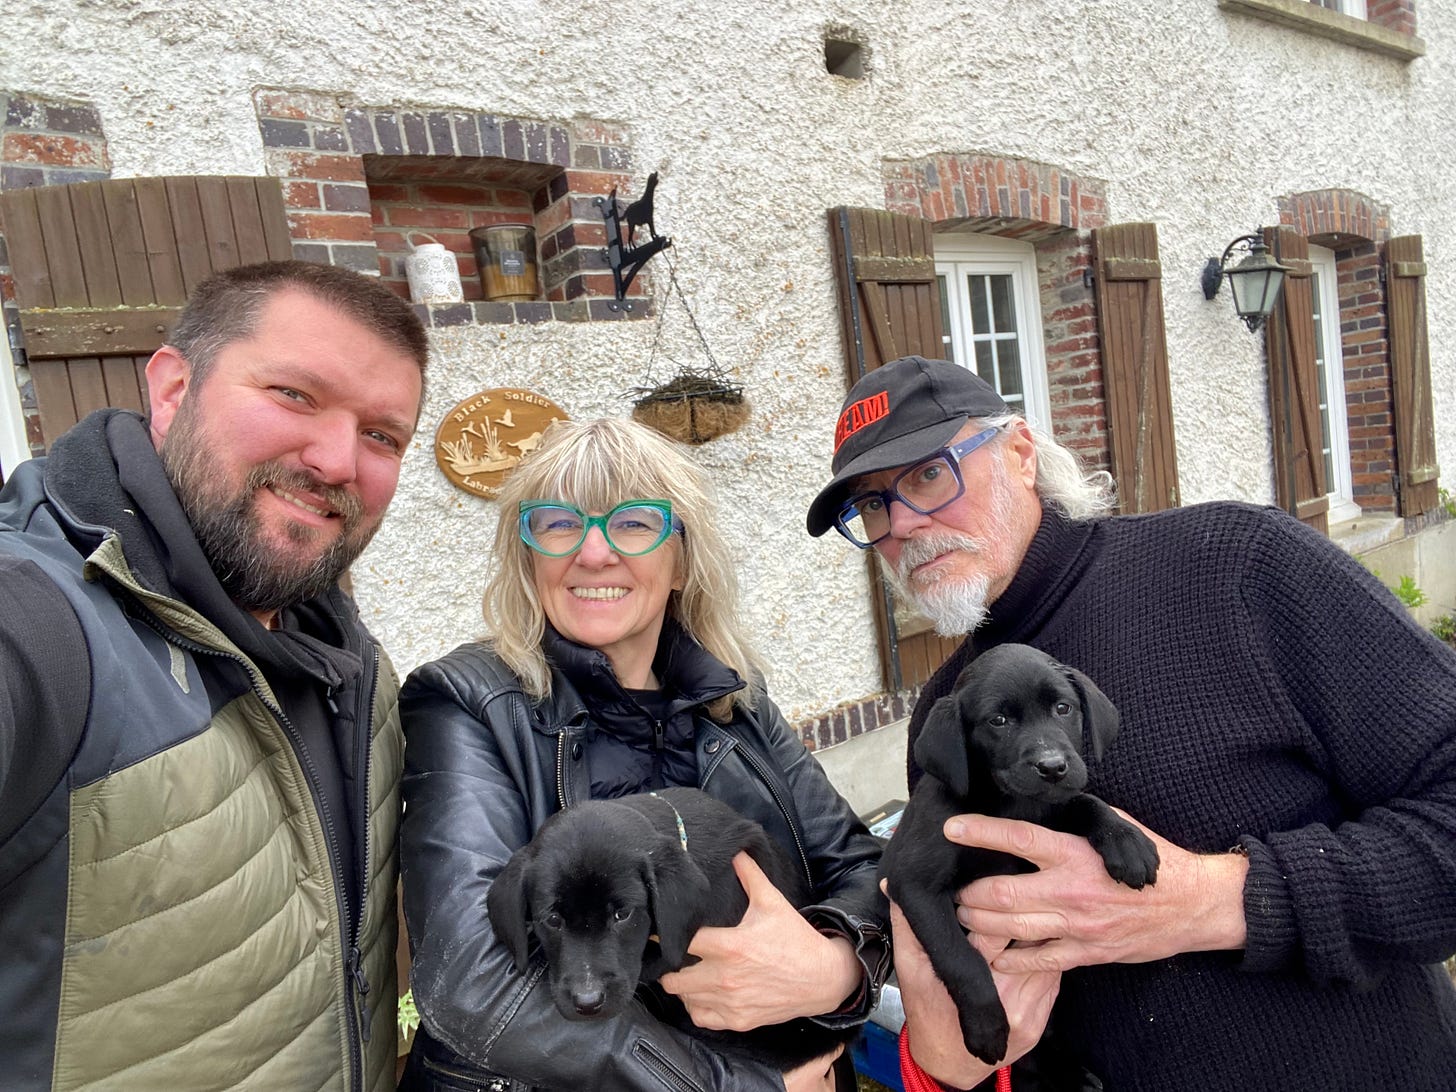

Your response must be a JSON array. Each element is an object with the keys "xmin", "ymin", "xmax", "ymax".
[{"xmin": 910, "ymin": 504, "xmax": 1456, "ymax": 1092}]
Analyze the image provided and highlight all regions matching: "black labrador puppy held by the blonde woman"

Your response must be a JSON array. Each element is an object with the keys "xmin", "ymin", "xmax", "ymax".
[{"xmin": 486, "ymin": 788, "xmax": 858, "ymax": 1072}]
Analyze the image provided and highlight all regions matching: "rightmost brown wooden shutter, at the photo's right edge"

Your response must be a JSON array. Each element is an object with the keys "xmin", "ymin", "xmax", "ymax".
[{"xmin": 1385, "ymin": 234, "xmax": 1440, "ymax": 515}]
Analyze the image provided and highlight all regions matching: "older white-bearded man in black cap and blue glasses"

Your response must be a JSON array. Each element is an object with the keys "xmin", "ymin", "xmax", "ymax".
[{"xmin": 808, "ymin": 357, "xmax": 1456, "ymax": 1092}]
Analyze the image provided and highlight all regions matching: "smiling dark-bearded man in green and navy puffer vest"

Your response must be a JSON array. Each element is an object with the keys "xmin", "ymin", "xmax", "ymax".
[{"xmin": 0, "ymin": 262, "xmax": 427, "ymax": 1092}]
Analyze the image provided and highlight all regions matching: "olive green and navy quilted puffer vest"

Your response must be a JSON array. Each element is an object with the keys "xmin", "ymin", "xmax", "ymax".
[{"xmin": 0, "ymin": 467, "xmax": 403, "ymax": 1092}]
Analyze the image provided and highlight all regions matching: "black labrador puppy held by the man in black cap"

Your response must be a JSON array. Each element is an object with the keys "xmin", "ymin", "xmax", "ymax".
[{"xmin": 879, "ymin": 645, "xmax": 1158, "ymax": 1088}]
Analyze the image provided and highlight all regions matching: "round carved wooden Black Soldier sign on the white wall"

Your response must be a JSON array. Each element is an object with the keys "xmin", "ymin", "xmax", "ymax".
[{"xmin": 435, "ymin": 387, "xmax": 566, "ymax": 496}]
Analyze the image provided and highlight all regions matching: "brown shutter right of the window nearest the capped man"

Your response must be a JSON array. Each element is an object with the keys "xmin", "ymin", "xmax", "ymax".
[{"xmin": 1092, "ymin": 224, "xmax": 1181, "ymax": 513}]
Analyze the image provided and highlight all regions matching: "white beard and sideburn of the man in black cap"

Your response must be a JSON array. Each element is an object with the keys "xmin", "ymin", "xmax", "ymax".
[{"xmin": 885, "ymin": 463, "xmax": 1012, "ymax": 636}]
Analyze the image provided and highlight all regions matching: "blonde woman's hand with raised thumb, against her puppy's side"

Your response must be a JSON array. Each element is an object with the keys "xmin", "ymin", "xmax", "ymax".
[{"xmin": 660, "ymin": 853, "xmax": 862, "ymax": 1031}]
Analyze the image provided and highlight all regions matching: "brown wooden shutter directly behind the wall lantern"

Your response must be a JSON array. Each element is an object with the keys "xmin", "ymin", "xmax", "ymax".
[{"xmin": 1264, "ymin": 227, "xmax": 1329, "ymax": 534}]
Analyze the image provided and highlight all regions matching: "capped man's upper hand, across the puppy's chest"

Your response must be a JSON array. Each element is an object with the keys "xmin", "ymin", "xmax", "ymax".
[{"xmin": 945, "ymin": 812, "xmax": 1249, "ymax": 973}]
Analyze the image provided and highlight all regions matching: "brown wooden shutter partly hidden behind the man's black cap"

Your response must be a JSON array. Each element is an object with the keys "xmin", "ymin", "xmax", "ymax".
[{"xmin": 828, "ymin": 208, "xmax": 960, "ymax": 690}]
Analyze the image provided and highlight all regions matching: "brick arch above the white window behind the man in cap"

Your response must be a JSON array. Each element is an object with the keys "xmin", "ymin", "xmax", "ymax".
[{"xmin": 882, "ymin": 151, "xmax": 1107, "ymax": 237}]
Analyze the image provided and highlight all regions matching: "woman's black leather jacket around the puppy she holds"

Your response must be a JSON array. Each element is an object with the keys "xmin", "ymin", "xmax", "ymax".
[{"xmin": 400, "ymin": 631, "xmax": 890, "ymax": 1092}]
